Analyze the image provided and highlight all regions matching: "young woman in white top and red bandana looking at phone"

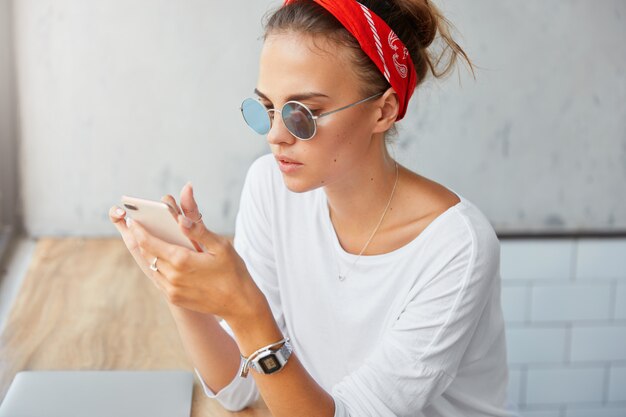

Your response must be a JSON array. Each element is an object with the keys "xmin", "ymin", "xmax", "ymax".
[{"xmin": 110, "ymin": 0, "xmax": 513, "ymax": 417}]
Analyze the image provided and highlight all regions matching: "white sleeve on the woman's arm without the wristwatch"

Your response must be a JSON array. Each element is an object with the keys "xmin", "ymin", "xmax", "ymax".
[{"xmin": 196, "ymin": 157, "xmax": 286, "ymax": 411}]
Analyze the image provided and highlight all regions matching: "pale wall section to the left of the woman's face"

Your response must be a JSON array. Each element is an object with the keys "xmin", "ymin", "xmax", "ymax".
[{"xmin": 16, "ymin": 0, "xmax": 276, "ymax": 235}]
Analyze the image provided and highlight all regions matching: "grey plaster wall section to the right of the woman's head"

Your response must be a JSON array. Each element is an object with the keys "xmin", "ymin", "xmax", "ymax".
[{"xmin": 404, "ymin": 0, "xmax": 626, "ymax": 233}]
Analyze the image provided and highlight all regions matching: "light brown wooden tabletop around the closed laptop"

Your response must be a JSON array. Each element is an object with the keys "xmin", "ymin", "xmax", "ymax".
[{"xmin": 0, "ymin": 238, "xmax": 270, "ymax": 417}]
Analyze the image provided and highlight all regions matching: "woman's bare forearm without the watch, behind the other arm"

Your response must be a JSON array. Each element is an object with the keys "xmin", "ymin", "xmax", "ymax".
[{"xmin": 168, "ymin": 303, "xmax": 240, "ymax": 393}]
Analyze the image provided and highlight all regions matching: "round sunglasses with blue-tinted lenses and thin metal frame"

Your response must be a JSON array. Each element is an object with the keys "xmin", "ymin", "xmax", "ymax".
[{"xmin": 241, "ymin": 93, "xmax": 383, "ymax": 140}]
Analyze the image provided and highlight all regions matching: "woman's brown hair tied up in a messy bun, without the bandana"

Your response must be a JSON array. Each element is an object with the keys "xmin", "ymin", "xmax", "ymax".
[{"xmin": 265, "ymin": 0, "xmax": 474, "ymax": 95}]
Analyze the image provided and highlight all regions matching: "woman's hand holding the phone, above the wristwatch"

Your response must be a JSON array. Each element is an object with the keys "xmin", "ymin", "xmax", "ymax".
[{"xmin": 110, "ymin": 184, "xmax": 265, "ymax": 321}]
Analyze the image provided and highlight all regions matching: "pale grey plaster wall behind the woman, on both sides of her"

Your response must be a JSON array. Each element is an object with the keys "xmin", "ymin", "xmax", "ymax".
[{"xmin": 11, "ymin": 0, "xmax": 626, "ymax": 235}]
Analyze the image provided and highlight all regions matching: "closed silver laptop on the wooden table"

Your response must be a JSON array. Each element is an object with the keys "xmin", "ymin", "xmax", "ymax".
[{"xmin": 0, "ymin": 371, "xmax": 194, "ymax": 417}]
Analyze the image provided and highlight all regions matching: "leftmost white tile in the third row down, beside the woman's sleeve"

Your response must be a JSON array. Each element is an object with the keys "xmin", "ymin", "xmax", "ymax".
[{"xmin": 506, "ymin": 327, "xmax": 567, "ymax": 364}]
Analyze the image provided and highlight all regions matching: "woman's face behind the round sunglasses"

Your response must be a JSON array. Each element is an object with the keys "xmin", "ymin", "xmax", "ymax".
[{"xmin": 257, "ymin": 32, "xmax": 380, "ymax": 192}]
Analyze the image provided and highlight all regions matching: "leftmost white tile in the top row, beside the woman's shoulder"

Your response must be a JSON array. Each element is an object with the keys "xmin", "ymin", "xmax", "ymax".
[{"xmin": 500, "ymin": 239, "xmax": 574, "ymax": 280}]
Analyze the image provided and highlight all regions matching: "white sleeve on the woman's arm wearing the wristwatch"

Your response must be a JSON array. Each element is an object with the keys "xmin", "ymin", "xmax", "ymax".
[{"xmin": 332, "ymin": 219, "xmax": 499, "ymax": 417}]
